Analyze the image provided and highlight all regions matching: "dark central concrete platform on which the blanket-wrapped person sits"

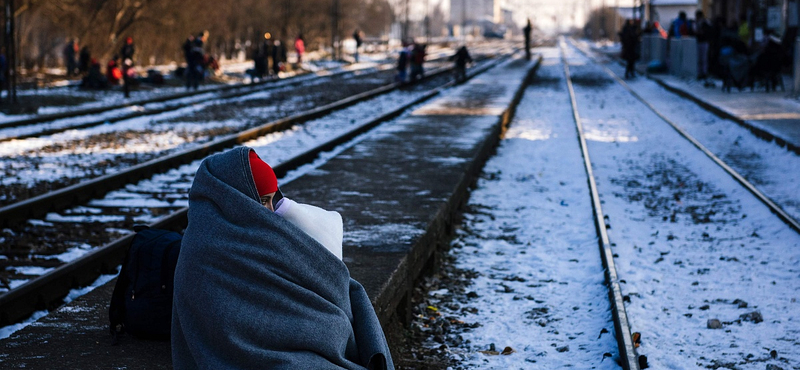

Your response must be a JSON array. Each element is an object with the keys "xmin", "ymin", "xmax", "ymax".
[{"xmin": 0, "ymin": 55, "xmax": 535, "ymax": 369}]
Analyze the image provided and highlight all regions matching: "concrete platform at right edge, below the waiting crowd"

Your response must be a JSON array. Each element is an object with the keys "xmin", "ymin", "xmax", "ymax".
[{"xmin": 640, "ymin": 71, "xmax": 800, "ymax": 154}]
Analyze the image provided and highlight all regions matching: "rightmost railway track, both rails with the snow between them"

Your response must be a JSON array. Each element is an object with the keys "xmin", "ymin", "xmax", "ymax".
[{"xmin": 561, "ymin": 41, "xmax": 800, "ymax": 369}]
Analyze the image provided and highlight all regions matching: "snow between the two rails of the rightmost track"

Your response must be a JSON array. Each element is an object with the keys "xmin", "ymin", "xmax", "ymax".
[{"xmin": 569, "ymin": 41, "xmax": 800, "ymax": 370}]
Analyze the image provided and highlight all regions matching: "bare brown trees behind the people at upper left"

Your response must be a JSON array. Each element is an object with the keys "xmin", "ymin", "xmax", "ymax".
[{"xmin": 4, "ymin": 0, "xmax": 393, "ymax": 67}]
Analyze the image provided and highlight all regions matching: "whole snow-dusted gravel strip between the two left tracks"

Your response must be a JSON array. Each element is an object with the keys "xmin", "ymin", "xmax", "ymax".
[{"xmin": 0, "ymin": 51, "xmax": 494, "ymax": 211}]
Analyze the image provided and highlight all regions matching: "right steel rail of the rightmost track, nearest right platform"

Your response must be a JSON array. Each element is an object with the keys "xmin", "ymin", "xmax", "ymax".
[{"xmin": 573, "ymin": 39, "xmax": 800, "ymax": 233}]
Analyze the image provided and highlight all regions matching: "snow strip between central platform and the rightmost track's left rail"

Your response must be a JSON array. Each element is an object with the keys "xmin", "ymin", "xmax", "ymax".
[{"xmin": 425, "ymin": 49, "xmax": 619, "ymax": 369}]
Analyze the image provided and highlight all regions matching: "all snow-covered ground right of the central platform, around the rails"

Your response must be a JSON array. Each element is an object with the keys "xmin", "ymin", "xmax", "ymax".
[{"xmin": 415, "ymin": 41, "xmax": 800, "ymax": 370}]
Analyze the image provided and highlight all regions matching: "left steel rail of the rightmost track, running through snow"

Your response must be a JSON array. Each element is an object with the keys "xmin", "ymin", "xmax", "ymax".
[{"xmin": 559, "ymin": 38, "xmax": 639, "ymax": 370}]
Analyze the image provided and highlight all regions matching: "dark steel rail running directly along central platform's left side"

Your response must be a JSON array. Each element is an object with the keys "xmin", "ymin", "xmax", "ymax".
[{"xmin": 0, "ymin": 52, "xmax": 508, "ymax": 326}]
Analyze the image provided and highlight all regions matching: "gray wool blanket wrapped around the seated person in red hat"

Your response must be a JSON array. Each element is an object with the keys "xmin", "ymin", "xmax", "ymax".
[{"xmin": 172, "ymin": 147, "xmax": 394, "ymax": 369}]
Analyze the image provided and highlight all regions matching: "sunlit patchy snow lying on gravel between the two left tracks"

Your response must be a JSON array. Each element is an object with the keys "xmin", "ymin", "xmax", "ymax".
[{"xmin": 0, "ymin": 66, "xmax": 396, "ymax": 194}]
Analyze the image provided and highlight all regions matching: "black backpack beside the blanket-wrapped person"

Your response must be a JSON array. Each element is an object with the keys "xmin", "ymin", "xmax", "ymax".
[{"xmin": 108, "ymin": 226, "xmax": 183, "ymax": 344}]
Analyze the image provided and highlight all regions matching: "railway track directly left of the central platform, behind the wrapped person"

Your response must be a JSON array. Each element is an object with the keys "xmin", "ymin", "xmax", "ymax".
[{"xmin": 0, "ymin": 48, "xmax": 502, "ymax": 325}]
